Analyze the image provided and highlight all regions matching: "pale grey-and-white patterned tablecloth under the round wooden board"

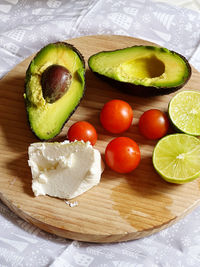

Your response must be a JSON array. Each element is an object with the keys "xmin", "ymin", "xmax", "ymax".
[{"xmin": 0, "ymin": 0, "xmax": 200, "ymax": 267}]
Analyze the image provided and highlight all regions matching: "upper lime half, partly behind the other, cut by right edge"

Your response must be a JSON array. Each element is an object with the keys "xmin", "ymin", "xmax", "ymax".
[{"xmin": 168, "ymin": 91, "xmax": 200, "ymax": 136}]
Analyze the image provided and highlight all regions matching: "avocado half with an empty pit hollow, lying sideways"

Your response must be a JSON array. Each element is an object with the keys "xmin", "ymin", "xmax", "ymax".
[{"xmin": 88, "ymin": 45, "xmax": 191, "ymax": 96}]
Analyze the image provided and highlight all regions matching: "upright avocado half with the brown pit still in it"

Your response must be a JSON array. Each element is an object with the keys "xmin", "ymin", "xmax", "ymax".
[{"xmin": 24, "ymin": 42, "xmax": 85, "ymax": 140}]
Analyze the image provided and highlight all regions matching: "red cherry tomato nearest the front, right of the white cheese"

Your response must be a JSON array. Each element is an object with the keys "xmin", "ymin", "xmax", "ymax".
[{"xmin": 105, "ymin": 137, "xmax": 141, "ymax": 173}]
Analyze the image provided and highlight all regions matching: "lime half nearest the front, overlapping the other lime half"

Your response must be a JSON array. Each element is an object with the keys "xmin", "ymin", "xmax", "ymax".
[{"xmin": 153, "ymin": 133, "xmax": 200, "ymax": 184}]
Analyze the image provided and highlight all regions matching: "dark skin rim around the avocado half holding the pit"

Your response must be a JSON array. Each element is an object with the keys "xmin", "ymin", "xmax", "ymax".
[{"xmin": 24, "ymin": 42, "xmax": 86, "ymax": 141}]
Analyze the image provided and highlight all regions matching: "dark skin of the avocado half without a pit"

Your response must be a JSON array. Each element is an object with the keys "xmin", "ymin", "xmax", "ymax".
[{"xmin": 88, "ymin": 45, "xmax": 192, "ymax": 97}]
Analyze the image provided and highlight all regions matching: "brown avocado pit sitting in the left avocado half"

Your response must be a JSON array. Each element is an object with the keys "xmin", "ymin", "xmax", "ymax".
[{"xmin": 41, "ymin": 64, "xmax": 72, "ymax": 103}]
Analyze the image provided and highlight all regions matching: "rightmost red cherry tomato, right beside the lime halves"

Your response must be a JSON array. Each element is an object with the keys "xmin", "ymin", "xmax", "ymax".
[{"xmin": 139, "ymin": 109, "xmax": 169, "ymax": 140}]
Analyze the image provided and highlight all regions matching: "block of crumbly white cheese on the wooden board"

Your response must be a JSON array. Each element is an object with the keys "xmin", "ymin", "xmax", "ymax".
[{"xmin": 28, "ymin": 141, "xmax": 104, "ymax": 199}]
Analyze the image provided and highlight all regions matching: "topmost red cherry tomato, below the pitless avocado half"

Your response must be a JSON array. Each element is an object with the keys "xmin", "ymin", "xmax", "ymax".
[{"xmin": 100, "ymin": 99, "xmax": 133, "ymax": 133}]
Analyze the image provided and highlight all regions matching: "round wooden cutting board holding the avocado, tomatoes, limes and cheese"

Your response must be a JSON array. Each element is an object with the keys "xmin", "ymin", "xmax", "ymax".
[{"xmin": 0, "ymin": 36, "xmax": 200, "ymax": 242}]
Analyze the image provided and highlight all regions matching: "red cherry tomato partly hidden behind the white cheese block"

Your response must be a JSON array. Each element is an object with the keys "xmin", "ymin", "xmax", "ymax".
[{"xmin": 67, "ymin": 121, "xmax": 97, "ymax": 146}]
